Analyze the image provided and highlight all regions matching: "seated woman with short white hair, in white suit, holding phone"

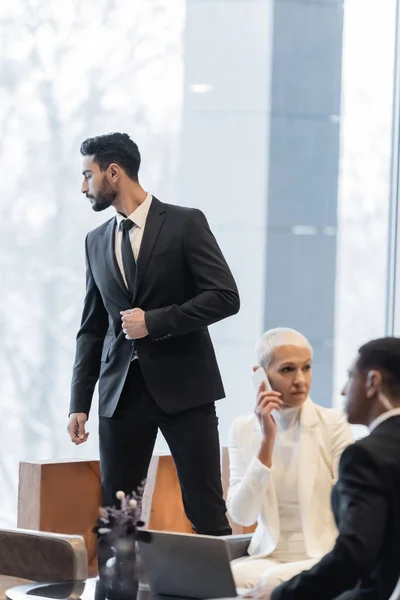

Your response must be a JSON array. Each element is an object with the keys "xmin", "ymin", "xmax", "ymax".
[{"xmin": 227, "ymin": 328, "xmax": 353, "ymax": 588}]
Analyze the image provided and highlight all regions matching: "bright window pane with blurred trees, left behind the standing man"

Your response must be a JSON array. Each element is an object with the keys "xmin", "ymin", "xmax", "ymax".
[{"xmin": 0, "ymin": 0, "xmax": 185, "ymax": 523}]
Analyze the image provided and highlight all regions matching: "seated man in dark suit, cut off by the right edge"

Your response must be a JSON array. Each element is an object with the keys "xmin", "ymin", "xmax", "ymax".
[{"xmin": 253, "ymin": 338, "xmax": 400, "ymax": 600}]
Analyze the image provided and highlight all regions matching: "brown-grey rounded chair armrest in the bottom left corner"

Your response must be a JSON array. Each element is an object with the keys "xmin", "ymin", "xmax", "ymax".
[{"xmin": 0, "ymin": 529, "xmax": 88, "ymax": 582}]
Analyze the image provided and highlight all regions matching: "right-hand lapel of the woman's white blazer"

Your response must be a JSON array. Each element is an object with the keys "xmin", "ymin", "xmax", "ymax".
[{"xmin": 298, "ymin": 398, "xmax": 319, "ymax": 519}]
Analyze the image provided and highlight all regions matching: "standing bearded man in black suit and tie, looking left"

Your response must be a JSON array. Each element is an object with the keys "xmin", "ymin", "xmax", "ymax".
[{"xmin": 68, "ymin": 133, "xmax": 239, "ymax": 535}]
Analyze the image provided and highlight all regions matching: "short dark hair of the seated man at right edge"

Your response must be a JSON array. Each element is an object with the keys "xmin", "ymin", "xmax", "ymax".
[{"xmin": 357, "ymin": 337, "xmax": 400, "ymax": 400}]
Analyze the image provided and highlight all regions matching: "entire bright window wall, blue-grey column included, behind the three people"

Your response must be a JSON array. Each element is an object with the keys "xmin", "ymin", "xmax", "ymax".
[{"xmin": 0, "ymin": 0, "xmax": 396, "ymax": 524}]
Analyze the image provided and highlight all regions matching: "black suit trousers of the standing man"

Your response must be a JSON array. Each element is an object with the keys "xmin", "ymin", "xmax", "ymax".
[{"xmin": 99, "ymin": 360, "xmax": 231, "ymax": 535}]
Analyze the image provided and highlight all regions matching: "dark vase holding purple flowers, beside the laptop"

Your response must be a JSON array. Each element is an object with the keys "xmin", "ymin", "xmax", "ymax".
[{"xmin": 102, "ymin": 536, "xmax": 139, "ymax": 600}]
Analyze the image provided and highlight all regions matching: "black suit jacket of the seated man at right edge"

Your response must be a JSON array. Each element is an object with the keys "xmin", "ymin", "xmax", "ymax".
[{"xmin": 271, "ymin": 416, "xmax": 400, "ymax": 600}]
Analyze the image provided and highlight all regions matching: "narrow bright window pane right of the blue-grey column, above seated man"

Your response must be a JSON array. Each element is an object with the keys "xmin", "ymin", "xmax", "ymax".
[{"xmin": 334, "ymin": 0, "xmax": 396, "ymax": 404}]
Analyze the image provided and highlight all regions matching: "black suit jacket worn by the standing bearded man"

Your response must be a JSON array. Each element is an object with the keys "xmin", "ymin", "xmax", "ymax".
[{"xmin": 70, "ymin": 197, "xmax": 239, "ymax": 417}]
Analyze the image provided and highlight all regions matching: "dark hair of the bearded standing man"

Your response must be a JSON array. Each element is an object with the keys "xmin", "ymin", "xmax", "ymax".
[{"xmin": 81, "ymin": 133, "xmax": 140, "ymax": 181}]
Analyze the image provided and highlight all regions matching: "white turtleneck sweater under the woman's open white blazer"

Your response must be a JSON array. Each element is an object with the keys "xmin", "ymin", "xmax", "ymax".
[{"xmin": 268, "ymin": 407, "xmax": 309, "ymax": 563}]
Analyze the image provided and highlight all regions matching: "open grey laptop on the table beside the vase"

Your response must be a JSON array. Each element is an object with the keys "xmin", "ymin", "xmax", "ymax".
[{"xmin": 139, "ymin": 531, "xmax": 237, "ymax": 599}]
